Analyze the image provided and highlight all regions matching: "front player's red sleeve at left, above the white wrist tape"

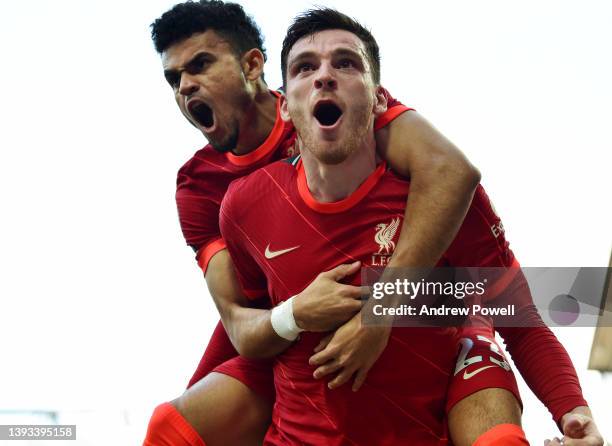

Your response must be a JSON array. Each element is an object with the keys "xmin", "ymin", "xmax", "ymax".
[{"xmin": 219, "ymin": 179, "xmax": 268, "ymax": 300}]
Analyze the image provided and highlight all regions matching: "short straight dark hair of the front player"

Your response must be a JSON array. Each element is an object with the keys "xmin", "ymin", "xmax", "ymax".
[{"xmin": 281, "ymin": 8, "xmax": 380, "ymax": 87}]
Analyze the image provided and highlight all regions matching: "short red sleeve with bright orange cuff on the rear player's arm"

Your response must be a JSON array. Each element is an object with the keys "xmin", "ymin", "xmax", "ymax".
[{"xmin": 176, "ymin": 159, "xmax": 225, "ymax": 272}]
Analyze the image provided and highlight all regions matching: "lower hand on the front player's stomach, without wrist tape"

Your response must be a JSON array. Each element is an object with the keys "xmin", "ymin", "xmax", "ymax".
[{"xmin": 308, "ymin": 314, "xmax": 391, "ymax": 392}]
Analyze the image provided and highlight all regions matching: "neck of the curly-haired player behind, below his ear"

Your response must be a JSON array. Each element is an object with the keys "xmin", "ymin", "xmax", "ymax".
[{"xmin": 233, "ymin": 79, "xmax": 276, "ymax": 155}]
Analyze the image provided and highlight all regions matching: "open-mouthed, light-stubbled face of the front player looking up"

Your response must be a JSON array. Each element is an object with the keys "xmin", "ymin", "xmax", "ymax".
[{"xmin": 281, "ymin": 29, "xmax": 386, "ymax": 164}]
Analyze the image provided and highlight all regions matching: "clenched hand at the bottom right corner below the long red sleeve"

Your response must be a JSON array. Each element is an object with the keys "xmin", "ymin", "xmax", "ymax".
[{"xmin": 544, "ymin": 407, "xmax": 604, "ymax": 446}]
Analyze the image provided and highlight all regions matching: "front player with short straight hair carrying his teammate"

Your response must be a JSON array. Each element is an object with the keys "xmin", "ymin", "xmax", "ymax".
[{"xmin": 219, "ymin": 6, "xmax": 599, "ymax": 445}]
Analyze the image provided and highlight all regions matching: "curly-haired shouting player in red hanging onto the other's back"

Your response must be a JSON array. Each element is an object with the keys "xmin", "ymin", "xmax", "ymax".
[{"xmin": 142, "ymin": 2, "xmax": 604, "ymax": 444}]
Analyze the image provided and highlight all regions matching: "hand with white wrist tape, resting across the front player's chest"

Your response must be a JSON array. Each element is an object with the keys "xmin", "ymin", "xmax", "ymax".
[{"xmin": 293, "ymin": 262, "xmax": 368, "ymax": 331}]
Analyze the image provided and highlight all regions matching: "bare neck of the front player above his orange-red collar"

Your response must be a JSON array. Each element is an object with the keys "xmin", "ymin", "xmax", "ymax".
[{"xmin": 301, "ymin": 134, "xmax": 378, "ymax": 203}]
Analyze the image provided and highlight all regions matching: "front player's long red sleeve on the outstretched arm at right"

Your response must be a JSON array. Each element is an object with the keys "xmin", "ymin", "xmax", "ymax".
[{"xmin": 447, "ymin": 186, "xmax": 587, "ymax": 422}]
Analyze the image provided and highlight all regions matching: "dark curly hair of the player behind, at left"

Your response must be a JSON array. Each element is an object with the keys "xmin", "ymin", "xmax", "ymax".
[{"xmin": 151, "ymin": 0, "xmax": 266, "ymax": 61}]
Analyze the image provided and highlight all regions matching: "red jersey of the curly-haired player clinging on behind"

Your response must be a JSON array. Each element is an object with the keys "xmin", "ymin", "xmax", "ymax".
[{"xmin": 176, "ymin": 91, "xmax": 412, "ymax": 386}]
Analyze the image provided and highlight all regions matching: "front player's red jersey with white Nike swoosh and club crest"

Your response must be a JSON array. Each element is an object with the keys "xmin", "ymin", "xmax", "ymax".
[{"xmin": 221, "ymin": 156, "xmax": 580, "ymax": 445}]
